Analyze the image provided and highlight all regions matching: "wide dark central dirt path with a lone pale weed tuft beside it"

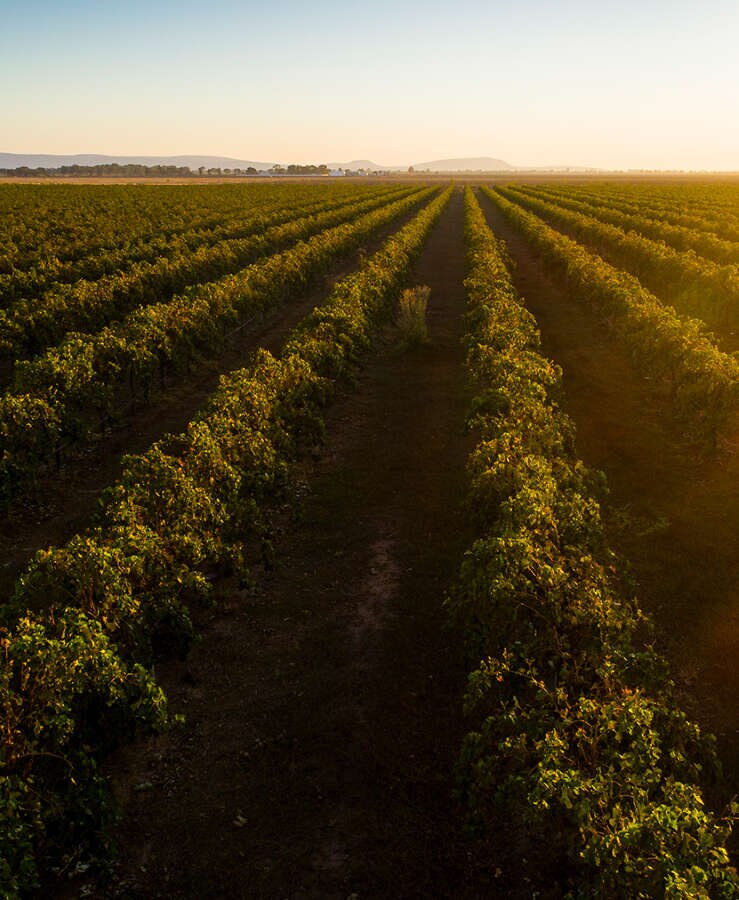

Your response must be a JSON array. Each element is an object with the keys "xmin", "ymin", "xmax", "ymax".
[{"xmin": 66, "ymin": 186, "xmax": 516, "ymax": 900}]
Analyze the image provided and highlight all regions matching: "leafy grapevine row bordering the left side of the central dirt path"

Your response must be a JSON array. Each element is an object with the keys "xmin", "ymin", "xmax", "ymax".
[{"xmin": 0, "ymin": 189, "xmax": 451, "ymax": 894}]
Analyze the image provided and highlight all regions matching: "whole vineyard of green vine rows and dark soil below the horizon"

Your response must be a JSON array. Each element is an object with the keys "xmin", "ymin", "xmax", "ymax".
[{"xmin": 0, "ymin": 180, "xmax": 739, "ymax": 898}]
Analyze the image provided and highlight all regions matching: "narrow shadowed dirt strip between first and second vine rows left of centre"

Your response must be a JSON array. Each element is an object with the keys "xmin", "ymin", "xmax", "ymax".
[{"xmin": 0, "ymin": 199, "xmax": 428, "ymax": 597}]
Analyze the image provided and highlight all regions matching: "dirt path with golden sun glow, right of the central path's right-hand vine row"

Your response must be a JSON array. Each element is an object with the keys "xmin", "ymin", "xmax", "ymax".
[{"xmin": 480, "ymin": 190, "xmax": 739, "ymax": 792}]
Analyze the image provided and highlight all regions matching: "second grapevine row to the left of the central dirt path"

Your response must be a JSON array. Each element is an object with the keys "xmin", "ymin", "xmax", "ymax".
[{"xmin": 0, "ymin": 188, "xmax": 433, "ymax": 500}]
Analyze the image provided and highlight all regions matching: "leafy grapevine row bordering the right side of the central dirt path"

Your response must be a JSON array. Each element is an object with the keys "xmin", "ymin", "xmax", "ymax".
[{"xmin": 450, "ymin": 189, "xmax": 739, "ymax": 900}]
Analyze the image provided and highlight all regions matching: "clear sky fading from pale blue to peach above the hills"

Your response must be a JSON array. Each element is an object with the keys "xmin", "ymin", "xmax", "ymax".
[{"xmin": 0, "ymin": 0, "xmax": 739, "ymax": 170}]
